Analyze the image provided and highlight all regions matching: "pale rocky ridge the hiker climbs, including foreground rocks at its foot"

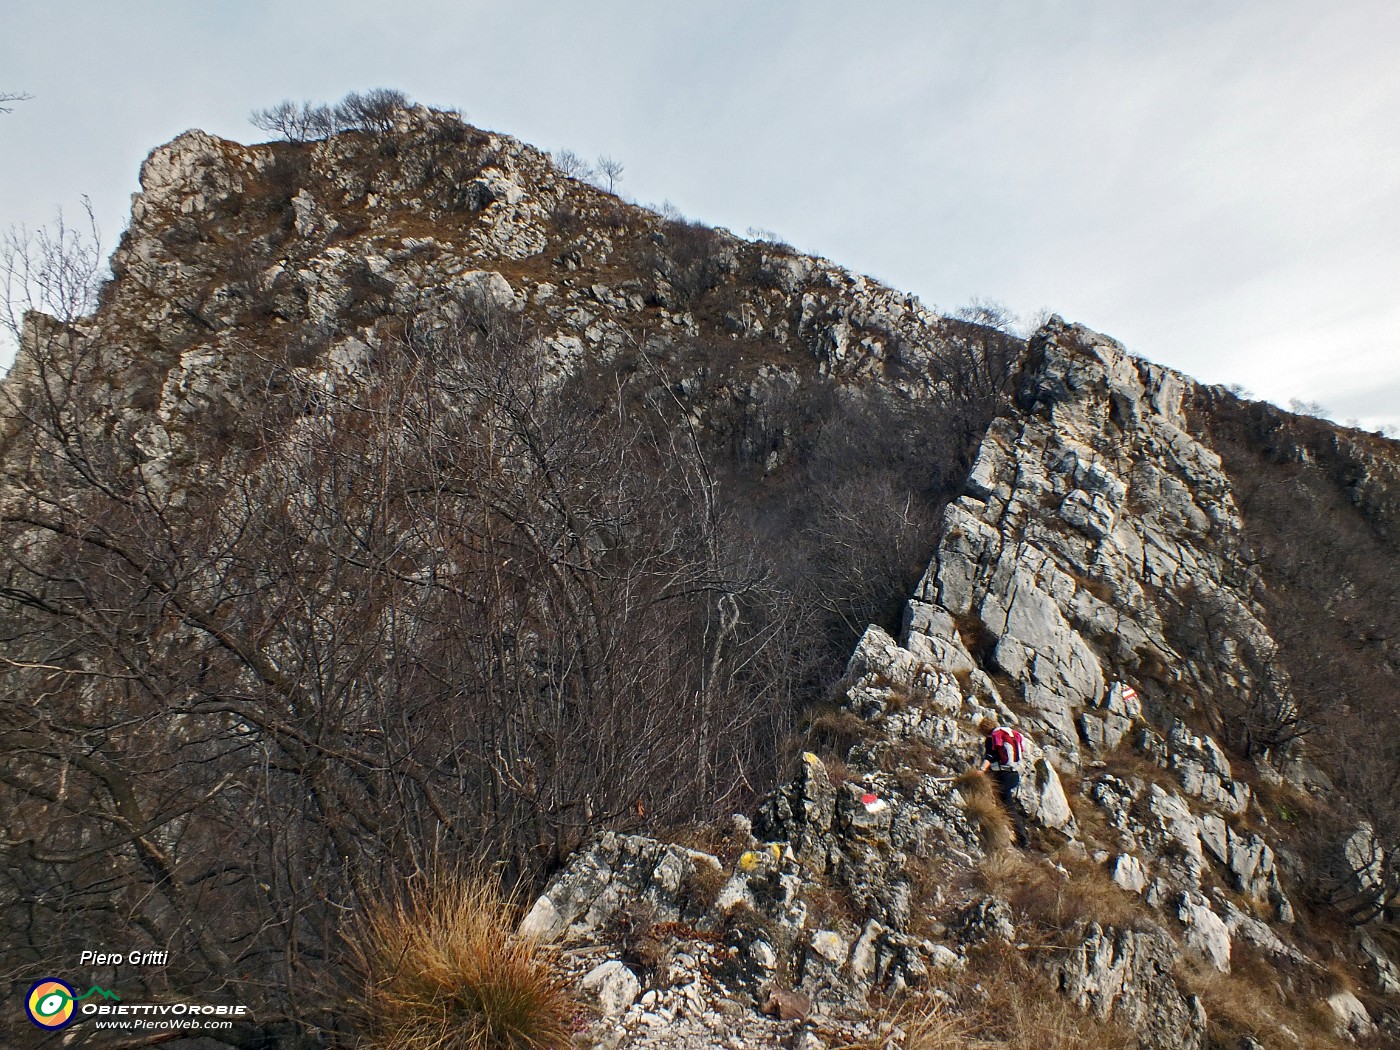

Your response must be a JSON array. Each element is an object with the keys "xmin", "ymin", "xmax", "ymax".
[{"xmin": 521, "ymin": 319, "xmax": 1393, "ymax": 1047}]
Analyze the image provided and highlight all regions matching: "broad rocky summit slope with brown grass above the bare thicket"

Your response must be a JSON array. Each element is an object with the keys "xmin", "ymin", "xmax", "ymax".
[{"xmin": 0, "ymin": 106, "xmax": 980, "ymax": 492}]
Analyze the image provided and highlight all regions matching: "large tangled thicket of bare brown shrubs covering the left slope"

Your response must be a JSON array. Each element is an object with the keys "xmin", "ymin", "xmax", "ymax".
[{"xmin": 0, "ymin": 224, "xmax": 791, "ymax": 1039}]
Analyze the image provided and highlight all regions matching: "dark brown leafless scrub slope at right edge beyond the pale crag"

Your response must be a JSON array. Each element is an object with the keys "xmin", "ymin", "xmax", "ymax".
[{"xmin": 1197, "ymin": 395, "xmax": 1400, "ymax": 923}]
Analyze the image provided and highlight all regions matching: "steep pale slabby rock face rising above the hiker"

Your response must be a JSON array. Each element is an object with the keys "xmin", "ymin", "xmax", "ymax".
[{"xmin": 907, "ymin": 321, "xmax": 1281, "ymax": 767}]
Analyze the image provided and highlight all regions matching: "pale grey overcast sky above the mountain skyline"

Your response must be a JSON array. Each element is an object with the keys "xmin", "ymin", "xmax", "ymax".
[{"xmin": 0, "ymin": 0, "xmax": 1400, "ymax": 427}]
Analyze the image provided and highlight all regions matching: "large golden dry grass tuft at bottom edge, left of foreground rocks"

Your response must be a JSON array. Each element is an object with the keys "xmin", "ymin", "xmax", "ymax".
[{"xmin": 351, "ymin": 876, "xmax": 578, "ymax": 1050}]
